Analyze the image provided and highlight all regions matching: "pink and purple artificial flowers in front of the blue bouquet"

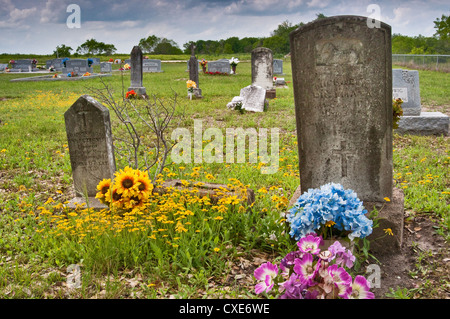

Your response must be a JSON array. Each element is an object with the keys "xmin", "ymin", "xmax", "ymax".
[{"xmin": 254, "ymin": 233, "xmax": 375, "ymax": 299}]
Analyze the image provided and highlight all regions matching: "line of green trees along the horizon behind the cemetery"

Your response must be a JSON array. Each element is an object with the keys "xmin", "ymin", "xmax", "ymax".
[{"xmin": 53, "ymin": 13, "xmax": 450, "ymax": 57}]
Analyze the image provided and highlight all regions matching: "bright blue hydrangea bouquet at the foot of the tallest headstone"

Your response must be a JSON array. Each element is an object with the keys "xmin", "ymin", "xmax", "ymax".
[{"xmin": 287, "ymin": 183, "xmax": 373, "ymax": 241}]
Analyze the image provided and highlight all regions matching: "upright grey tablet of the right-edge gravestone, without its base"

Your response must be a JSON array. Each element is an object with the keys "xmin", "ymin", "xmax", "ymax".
[{"xmin": 392, "ymin": 69, "xmax": 421, "ymax": 115}]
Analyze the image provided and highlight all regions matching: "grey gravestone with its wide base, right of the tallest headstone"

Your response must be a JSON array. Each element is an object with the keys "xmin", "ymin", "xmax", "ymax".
[{"xmin": 392, "ymin": 69, "xmax": 449, "ymax": 136}]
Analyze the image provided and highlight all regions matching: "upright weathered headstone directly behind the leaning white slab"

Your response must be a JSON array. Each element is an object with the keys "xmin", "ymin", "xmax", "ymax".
[{"xmin": 252, "ymin": 47, "xmax": 273, "ymax": 90}]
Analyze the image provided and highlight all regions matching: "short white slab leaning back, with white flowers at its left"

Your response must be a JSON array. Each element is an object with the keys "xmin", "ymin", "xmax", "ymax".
[{"xmin": 227, "ymin": 85, "xmax": 268, "ymax": 112}]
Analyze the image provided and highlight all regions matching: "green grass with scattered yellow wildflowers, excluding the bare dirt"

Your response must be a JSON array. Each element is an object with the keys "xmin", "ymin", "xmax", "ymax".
[{"xmin": 0, "ymin": 57, "xmax": 450, "ymax": 298}]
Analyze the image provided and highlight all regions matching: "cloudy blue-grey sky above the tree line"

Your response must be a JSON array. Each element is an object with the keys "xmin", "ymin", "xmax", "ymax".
[{"xmin": 0, "ymin": 0, "xmax": 450, "ymax": 54}]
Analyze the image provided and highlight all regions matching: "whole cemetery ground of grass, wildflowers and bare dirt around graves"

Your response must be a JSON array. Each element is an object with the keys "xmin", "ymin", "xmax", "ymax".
[{"xmin": 0, "ymin": 57, "xmax": 450, "ymax": 299}]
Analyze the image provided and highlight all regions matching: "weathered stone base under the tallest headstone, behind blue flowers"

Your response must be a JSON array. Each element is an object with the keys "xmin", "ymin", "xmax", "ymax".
[{"xmin": 288, "ymin": 186, "xmax": 404, "ymax": 256}]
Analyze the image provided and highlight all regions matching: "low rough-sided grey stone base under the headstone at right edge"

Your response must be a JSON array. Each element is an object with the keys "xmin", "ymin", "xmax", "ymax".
[{"xmin": 394, "ymin": 112, "xmax": 449, "ymax": 136}]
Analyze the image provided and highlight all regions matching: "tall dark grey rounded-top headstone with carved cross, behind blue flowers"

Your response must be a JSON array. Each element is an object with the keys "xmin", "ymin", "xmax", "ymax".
[{"xmin": 290, "ymin": 16, "xmax": 393, "ymax": 202}]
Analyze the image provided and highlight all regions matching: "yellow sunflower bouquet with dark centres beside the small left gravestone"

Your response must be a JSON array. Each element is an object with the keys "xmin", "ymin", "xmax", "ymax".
[{"xmin": 95, "ymin": 166, "xmax": 153, "ymax": 211}]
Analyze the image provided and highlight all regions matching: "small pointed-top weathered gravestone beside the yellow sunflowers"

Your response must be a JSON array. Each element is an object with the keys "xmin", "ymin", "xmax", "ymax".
[{"xmin": 64, "ymin": 95, "xmax": 116, "ymax": 207}]
